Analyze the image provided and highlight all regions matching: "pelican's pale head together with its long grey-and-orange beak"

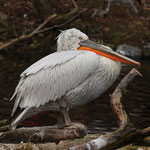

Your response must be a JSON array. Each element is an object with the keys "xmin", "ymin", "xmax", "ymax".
[{"xmin": 57, "ymin": 28, "xmax": 140, "ymax": 66}]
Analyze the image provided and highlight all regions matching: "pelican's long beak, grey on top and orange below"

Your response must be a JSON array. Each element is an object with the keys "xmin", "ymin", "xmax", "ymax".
[{"xmin": 78, "ymin": 40, "xmax": 141, "ymax": 66}]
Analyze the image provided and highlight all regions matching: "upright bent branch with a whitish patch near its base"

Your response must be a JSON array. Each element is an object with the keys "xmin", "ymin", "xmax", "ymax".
[{"xmin": 69, "ymin": 69, "xmax": 142, "ymax": 150}]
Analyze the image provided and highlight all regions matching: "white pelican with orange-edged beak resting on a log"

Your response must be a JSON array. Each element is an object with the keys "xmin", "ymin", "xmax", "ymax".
[{"xmin": 11, "ymin": 28, "xmax": 140, "ymax": 129}]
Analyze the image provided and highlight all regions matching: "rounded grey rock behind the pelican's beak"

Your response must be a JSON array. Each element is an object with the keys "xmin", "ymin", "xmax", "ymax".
[{"xmin": 116, "ymin": 44, "xmax": 141, "ymax": 60}]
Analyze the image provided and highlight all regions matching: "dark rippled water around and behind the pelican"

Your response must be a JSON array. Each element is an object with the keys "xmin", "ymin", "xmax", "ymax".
[{"xmin": 0, "ymin": 60, "xmax": 150, "ymax": 133}]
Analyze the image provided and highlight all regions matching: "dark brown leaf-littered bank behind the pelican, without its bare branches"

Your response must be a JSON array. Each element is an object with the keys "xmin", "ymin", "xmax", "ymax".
[{"xmin": 0, "ymin": 0, "xmax": 150, "ymax": 58}]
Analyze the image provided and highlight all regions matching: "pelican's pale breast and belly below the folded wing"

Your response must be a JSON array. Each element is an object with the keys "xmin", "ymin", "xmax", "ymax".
[{"xmin": 63, "ymin": 56, "xmax": 121, "ymax": 108}]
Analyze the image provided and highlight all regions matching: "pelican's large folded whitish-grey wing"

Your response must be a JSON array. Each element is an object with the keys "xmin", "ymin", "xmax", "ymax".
[{"xmin": 12, "ymin": 51, "xmax": 98, "ymax": 115}]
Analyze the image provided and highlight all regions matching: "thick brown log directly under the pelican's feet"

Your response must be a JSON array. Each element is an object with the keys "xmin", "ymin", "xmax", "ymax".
[{"xmin": 0, "ymin": 123, "xmax": 87, "ymax": 143}]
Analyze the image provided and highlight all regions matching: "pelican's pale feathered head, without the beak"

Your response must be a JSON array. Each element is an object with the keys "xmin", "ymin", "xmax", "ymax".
[{"xmin": 57, "ymin": 28, "xmax": 88, "ymax": 51}]
